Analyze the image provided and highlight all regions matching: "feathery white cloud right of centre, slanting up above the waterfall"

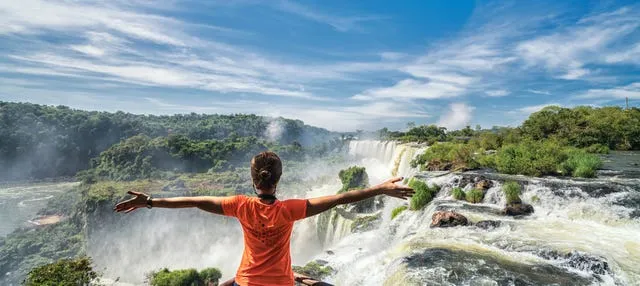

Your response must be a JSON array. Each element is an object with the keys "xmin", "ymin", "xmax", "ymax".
[{"xmin": 353, "ymin": 12, "xmax": 516, "ymax": 100}]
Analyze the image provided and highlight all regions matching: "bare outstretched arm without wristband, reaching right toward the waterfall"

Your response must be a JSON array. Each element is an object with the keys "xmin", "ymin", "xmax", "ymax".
[{"xmin": 306, "ymin": 177, "xmax": 414, "ymax": 217}]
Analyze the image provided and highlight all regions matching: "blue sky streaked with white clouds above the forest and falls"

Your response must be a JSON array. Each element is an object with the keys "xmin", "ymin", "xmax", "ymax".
[{"xmin": 0, "ymin": 0, "xmax": 640, "ymax": 131}]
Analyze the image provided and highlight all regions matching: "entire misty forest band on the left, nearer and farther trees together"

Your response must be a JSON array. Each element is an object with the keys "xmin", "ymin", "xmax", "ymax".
[{"xmin": 0, "ymin": 102, "xmax": 340, "ymax": 180}]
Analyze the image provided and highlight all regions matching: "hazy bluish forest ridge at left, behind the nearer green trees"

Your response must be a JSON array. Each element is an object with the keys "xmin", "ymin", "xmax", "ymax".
[{"xmin": 0, "ymin": 102, "xmax": 339, "ymax": 180}]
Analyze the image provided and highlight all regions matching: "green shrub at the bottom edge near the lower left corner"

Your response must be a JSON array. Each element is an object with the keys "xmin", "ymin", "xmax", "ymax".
[{"xmin": 24, "ymin": 257, "xmax": 98, "ymax": 286}]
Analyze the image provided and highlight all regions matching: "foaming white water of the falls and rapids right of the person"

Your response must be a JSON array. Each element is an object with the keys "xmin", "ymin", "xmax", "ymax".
[{"xmin": 302, "ymin": 141, "xmax": 640, "ymax": 285}]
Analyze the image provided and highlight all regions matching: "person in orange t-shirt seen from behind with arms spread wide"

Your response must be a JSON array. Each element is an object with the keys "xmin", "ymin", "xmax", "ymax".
[{"xmin": 114, "ymin": 152, "xmax": 414, "ymax": 286}]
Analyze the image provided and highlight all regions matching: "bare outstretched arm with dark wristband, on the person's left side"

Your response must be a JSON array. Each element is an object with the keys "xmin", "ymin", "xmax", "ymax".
[{"xmin": 113, "ymin": 191, "xmax": 223, "ymax": 214}]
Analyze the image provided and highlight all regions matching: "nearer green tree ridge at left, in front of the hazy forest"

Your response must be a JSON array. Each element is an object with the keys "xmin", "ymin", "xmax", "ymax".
[{"xmin": 79, "ymin": 135, "xmax": 342, "ymax": 182}]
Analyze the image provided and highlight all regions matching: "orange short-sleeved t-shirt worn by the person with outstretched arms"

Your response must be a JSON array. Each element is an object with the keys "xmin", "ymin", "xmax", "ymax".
[{"xmin": 222, "ymin": 196, "xmax": 307, "ymax": 286}]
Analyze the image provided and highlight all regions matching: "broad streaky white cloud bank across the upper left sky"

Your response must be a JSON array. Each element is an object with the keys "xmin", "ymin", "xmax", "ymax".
[{"xmin": 0, "ymin": 0, "xmax": 393, "ymax": 100}]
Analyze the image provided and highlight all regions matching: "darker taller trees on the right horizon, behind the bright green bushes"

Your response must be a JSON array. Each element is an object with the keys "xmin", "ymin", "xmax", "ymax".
[{"xmin": 377, "ymin": 106, "xmax": 640, "ymax": 150}]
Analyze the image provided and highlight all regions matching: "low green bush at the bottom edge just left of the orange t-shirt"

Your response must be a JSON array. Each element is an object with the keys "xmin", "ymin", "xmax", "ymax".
[{"xmin": 148, "ymin": 268, "xmax": 222, "ymax": 286}]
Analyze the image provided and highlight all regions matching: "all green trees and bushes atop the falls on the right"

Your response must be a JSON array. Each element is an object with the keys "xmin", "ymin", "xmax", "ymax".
[{"xmin": 378, "ymin": 106, "xmax": 640, "ymax": 178}]
